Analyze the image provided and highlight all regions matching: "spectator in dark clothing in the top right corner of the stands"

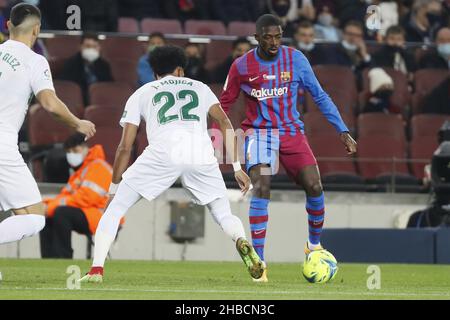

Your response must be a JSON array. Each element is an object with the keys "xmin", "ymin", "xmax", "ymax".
[{"xmin": 403, "ymin": 0, "xmax": 444, "ymax": 44}]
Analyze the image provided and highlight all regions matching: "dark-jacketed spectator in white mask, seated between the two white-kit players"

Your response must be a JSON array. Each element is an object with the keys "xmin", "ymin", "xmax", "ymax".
[{"xmin": 61, "ymin": 34, "xmax": 113, "ymax": 106}]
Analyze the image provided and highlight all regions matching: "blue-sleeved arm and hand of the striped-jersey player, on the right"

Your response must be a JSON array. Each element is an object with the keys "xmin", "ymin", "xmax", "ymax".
[{"xmin": 297, "ymin": 52, "xmax": 356, "ymax": 154}]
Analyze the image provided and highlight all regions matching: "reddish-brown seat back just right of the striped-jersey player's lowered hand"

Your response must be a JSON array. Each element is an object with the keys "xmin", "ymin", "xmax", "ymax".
[{"xmin": 357, "ymin": 112, "xmax": 406, "ymax": 141}]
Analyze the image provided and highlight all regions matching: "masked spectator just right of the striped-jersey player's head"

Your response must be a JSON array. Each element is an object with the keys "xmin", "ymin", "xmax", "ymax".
[{"xmin": 294, "ymin": 20, "xmax": 325, "ymax": 65}]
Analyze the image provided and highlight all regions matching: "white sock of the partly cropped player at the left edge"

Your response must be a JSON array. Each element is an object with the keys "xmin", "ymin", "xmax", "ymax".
[{"xmin": 0, "ymin": 214, "xmax": 45, "ymax": 244}]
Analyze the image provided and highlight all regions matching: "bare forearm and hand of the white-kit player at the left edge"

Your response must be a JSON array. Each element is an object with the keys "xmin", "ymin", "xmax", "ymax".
[{"xmin": 36, "ymin": 89, "xmax": 95, "ymax": 139}]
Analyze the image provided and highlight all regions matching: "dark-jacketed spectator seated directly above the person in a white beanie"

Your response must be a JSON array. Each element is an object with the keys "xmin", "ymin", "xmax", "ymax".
[{"xmin": 372, "ymin": 26, "xmax": 416, "ymax": 80}]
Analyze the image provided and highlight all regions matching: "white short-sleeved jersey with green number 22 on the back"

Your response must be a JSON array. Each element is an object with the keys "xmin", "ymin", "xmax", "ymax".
[{"xmin": 120, "ymin": 76, "xmax": 219, "ymax": 165}]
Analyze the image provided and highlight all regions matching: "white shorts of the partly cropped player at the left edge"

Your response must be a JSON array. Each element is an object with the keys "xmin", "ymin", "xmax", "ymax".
[{"xmin": 0, "ymin": 163, "xmax": 42, "ymax": 211}]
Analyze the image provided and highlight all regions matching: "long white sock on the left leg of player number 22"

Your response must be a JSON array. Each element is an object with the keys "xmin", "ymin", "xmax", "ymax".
[{"xmin": 92, "ymin": 182, "xmax": 141, "ymax": 267}]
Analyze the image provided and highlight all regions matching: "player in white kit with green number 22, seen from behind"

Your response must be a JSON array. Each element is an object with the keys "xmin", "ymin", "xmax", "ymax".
[{"xmin": 80, "ymin": 46, "xmax": 264, "ymax": 282}]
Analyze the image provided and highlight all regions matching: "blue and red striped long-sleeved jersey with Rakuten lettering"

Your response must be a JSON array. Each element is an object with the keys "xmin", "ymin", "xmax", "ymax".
[{"xmin": 220, "ymin": 46, "xmax": 349, "ymax": 135}]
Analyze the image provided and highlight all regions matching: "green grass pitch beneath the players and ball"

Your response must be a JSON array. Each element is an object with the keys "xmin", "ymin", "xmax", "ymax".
[{"xmin": 0, "ymin": 259, "xmax": 450, "ymax": 300}]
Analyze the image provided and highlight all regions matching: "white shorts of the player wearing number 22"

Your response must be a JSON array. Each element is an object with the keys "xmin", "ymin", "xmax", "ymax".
[{"xmin": 122, "ymin": 148, "xmax": 226, "ymax": 205}]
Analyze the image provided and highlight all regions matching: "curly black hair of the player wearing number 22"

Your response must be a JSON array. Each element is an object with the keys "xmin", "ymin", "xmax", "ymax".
[{"xmin": 149, "ymin": 45, "xmax": 187, "ymax": 76}]
